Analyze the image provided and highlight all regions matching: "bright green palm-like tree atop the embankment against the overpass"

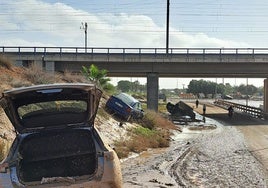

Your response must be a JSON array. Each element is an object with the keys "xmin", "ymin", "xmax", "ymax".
[{"xmin": 81, "ymin": 64, "xmax": 110, "ymax": 89}]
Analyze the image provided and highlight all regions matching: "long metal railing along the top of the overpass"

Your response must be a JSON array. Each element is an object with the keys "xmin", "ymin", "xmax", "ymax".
[{"xmin": 0, "ymin": 46, "xmax": 268, "ymax": 55}]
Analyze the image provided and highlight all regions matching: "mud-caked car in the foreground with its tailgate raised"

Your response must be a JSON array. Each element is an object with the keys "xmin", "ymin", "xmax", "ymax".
[{"xmin": 0, "ymin": 83, "xmax": 122, "ymax": 188}]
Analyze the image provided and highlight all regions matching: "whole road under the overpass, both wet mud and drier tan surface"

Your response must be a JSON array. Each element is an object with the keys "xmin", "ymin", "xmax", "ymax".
[{"xmin": 121, "ymin": 101, "xmax": 268, "ymax": 188}]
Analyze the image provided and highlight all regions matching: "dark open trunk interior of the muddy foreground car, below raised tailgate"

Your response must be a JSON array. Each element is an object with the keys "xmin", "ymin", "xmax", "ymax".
[{"xmin": 17, "ymin": 129, "xmax": 97, "ymax": 183}]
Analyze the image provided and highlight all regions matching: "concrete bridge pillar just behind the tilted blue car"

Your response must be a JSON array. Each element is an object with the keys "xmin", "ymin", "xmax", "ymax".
[{"xmin": 147, "ymin": 73, "xmax": 159, "ymax": 112}]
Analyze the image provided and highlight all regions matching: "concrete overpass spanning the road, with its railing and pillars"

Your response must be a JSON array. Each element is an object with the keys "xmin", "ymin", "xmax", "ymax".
[{"xmin": 0, "ymin": 46, "xmax": 268, "ymax": 112}]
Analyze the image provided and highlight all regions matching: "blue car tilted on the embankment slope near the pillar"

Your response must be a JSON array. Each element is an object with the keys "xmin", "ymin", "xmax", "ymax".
[{"xmin": 105, "ymin": 93, "xmax": 144, "ymax": 121}]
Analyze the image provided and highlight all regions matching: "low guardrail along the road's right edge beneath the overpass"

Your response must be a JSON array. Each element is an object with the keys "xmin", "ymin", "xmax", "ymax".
[{"xmin": 214, "ymin": 100, "xmax": 266, "ymax": 118}]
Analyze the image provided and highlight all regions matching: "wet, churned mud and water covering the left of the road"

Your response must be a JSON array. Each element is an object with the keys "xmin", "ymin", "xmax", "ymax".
[{"xmin": 122, "ymin": 118, "xmax": 267, "ymax": 188}]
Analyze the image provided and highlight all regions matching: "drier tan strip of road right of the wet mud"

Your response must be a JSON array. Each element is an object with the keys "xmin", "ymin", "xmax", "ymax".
[{"xmin": 187, "ymin": 102, "xmax": 268, "ymax": 172}]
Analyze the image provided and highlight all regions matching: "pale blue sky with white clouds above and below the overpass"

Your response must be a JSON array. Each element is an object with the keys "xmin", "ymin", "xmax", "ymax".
[{"xmin": 0, "ymin": 0, "xmax": 268, "ymax": 88}]
